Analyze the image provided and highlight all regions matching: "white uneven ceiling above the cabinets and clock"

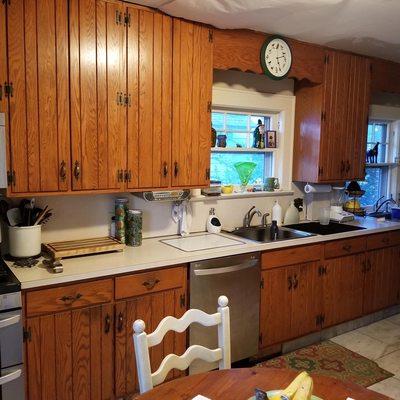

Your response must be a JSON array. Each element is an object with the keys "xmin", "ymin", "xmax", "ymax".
[{"xmin": 132, "ymin": 0, "xmax": 400, "ymax": 62}]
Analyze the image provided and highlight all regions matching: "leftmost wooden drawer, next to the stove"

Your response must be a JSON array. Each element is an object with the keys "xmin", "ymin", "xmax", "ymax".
[{"xmin": 26, "ymin": 279, "xmax": 113, "ymax": 317}]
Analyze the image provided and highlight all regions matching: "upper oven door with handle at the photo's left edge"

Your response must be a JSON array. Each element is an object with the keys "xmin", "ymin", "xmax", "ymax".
[{"xmin": 0, "ymin": 310, "xmax": 23, "ymax": 370}]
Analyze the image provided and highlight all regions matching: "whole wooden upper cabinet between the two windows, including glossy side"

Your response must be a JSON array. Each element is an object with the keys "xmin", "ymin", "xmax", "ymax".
[{"xmin": 293, "ymin": 50, "xmax": 371, "ymax": 182}]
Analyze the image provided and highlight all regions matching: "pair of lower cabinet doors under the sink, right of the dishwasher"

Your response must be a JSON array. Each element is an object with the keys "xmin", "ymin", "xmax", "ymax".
[{"xmin": 260, "ymin": 262, "xmax": 321, "ymax": 348}]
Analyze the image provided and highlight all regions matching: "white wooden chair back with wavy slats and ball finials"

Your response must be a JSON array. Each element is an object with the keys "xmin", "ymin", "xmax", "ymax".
[{"xmin": 133, "ymin": 296, "xmax": 231, "ymax": 393}]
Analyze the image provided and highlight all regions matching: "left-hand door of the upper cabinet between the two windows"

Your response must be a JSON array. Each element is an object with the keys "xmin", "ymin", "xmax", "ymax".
[{"xmin": 319, "ymin": 51, "xmax": 351, "ymax": 181}]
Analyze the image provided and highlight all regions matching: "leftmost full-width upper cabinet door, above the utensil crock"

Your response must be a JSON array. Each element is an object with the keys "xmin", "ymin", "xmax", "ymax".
[{"xmin": 6, "ymin": 0, "xmax": 70, "ymax": 193}]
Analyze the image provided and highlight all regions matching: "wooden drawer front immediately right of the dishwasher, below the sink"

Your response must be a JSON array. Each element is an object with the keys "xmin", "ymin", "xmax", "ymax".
[{"xmin": 261, "ymin": 245, "xmax": 322, "ymax": 269}]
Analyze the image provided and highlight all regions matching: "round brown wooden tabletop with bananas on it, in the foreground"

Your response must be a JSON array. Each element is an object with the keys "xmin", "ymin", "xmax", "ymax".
[{"xmin": 136, "ymin": 367, "xmax": 390, "ymax": 400}]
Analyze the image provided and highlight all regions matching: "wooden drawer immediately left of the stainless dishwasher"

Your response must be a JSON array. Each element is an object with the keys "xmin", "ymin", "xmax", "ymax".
[{"xmin": 115, "ymin": 266, "xmax": 186, "ymax": 299}]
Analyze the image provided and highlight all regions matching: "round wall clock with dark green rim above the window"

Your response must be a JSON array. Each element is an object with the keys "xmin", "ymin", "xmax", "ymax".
[{"xmin": 261, "ymin": 37, "xmax": 292, "ymax": 79}]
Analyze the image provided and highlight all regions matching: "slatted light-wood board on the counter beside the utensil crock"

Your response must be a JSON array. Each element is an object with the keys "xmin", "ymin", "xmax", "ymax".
[{"xmin": 42, "ymin": 237, "xmax": 125, "ymax": 259}]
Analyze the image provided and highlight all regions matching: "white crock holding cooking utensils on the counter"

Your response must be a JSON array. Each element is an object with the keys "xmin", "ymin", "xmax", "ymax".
[{"xmin": 8, "ymin": 225, "xmax": 42, "ymax": 258}]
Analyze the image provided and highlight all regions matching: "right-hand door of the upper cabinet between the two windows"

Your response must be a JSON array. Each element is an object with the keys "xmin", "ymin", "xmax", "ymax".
[{"xmin": 342, "ymin": 56, "xmax": 371, "ymax": 180}]
